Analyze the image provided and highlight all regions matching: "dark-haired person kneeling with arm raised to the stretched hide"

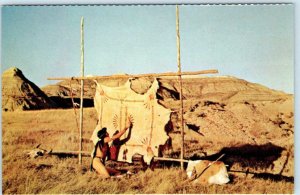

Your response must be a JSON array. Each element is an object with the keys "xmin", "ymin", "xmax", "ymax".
[{"xmin": 92, "ymin": 119, "xmax": 132, "ymax": 178}]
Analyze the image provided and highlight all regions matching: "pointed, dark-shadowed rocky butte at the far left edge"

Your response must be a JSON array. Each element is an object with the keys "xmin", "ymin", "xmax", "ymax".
[{"xmin": 2, "ymin": 67, "xmax": 57, "ymax": 111}]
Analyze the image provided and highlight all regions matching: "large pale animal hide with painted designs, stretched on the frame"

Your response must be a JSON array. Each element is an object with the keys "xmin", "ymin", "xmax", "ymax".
[{"xmin": 91, "ymin": 79, "xmax": 171, "ymax": 162}]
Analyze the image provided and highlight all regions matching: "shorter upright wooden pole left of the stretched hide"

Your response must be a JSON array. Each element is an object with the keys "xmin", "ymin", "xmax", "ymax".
[{"xmin": 78, "ymin": 17, "xmax": 84, "ymax": 164}]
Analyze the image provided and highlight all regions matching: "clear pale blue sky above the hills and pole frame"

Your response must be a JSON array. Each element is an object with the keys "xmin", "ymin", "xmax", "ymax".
[{"xmin": 1, "ymin": 5, "xmax": 294, "ymax": 93}]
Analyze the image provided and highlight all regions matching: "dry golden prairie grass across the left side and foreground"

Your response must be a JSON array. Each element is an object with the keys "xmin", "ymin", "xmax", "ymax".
[{"xmin": 2, "ymin": 108, "xmax": 294, "ymax": 194}]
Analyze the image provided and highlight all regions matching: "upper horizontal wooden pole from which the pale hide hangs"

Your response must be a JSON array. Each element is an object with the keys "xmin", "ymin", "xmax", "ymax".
[{"xmin": 48, "ymin": 70, "xmax": 219, "ymax": 80}]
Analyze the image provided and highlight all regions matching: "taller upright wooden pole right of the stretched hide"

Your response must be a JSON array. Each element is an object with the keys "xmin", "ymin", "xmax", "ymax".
[{"xmin": 176, "ymin": 5, "xmax": 184, "ymax": 170}]
